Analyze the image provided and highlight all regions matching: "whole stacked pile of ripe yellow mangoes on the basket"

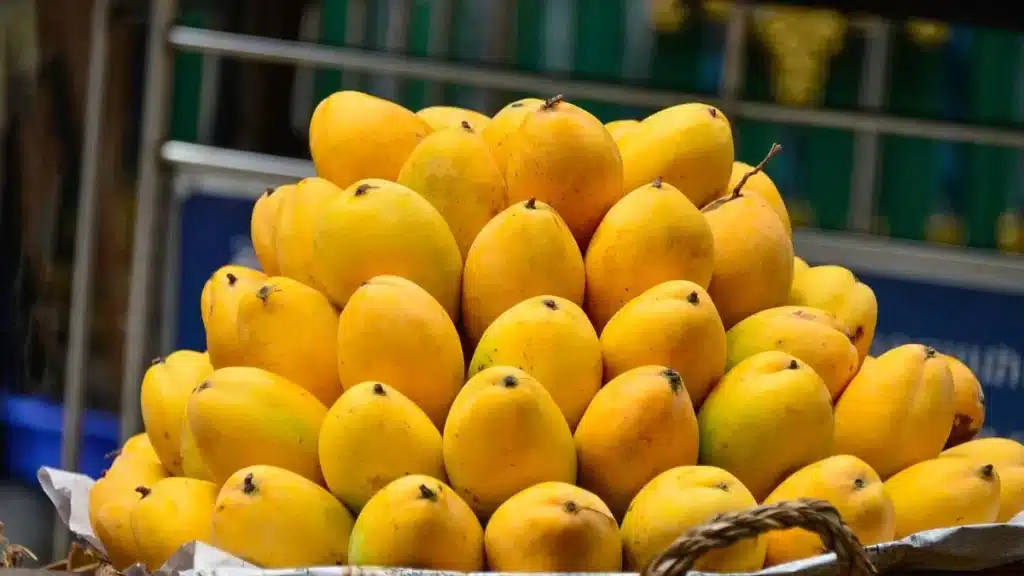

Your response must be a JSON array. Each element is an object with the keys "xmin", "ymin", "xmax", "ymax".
[{"xmin": 89, "ymin": 91, "xmax": 1024, "ymax": 572}]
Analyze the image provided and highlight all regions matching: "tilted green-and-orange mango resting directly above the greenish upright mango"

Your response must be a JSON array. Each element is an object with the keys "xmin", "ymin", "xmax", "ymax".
[{"xmin": 725, "ymin": 306, "xmax": 860, "ymax": 400}]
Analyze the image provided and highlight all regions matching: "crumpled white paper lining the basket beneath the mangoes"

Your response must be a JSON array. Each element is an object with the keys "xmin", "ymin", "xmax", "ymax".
[{"xmin": 37, "ymin": 466, "xmax": 1024, "ymax": 576}]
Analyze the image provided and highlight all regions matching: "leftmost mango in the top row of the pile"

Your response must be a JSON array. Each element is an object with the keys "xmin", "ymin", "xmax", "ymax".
[{"xmin": 309, "ymin": 90, "xmax": 433, "ymax": 188}]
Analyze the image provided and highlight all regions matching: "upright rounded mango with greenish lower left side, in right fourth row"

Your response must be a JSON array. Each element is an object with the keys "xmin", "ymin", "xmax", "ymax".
[{"xmin": 697, "ymin": 351, "xmax": 835, "ymax": 501}]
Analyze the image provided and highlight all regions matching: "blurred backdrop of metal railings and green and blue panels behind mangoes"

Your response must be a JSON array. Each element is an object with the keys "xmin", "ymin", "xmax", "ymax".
[{"xmin": 0, "ymin": 0, "xmax": 1024, "ymax": 560}]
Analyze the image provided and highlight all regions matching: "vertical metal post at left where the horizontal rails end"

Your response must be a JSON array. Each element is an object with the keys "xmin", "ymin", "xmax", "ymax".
[{"xmin": 121, "ymin": 0, "xmax": 176, "ymax": 440}]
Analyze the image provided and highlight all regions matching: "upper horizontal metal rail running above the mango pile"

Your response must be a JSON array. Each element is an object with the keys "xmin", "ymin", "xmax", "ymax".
[{"xmin": 170, "ymin": 27, "xmax": 1024, "ymax": 149}]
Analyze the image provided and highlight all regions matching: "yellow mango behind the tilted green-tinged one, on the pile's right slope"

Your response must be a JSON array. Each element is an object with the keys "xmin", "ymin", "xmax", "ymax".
[{"xmin": 790, "ymin": 265, "xmax": 879, "ymax": 358}]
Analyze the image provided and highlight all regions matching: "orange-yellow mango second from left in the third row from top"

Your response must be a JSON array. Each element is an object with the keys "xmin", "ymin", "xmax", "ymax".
[{"xmin": 238, "ymin": 276, "xmax": 341, "ymax": 406}]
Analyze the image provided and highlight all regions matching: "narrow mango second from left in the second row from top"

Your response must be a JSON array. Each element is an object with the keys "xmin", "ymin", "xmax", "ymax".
[{"xmin": 274, "ymin": 178, "xmax": 341, "ymax": 290}]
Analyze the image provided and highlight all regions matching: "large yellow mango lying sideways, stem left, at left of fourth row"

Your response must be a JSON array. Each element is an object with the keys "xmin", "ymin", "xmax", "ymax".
[{"xmin": 186, "ymin": 368, "xmax": 327, "ymax": 484}]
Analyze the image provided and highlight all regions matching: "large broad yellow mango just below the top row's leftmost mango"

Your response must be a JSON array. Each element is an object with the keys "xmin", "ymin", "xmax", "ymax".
[{"xmin": 312, "ymin": 179, "xmax": 462, "ymax": 320}]
